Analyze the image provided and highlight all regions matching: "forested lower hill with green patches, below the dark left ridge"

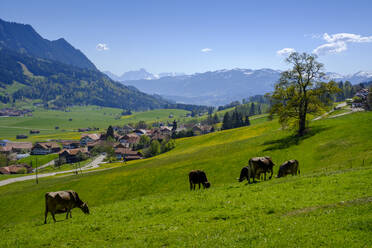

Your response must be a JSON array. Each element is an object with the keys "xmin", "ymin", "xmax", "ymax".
[{"xmin": 0, "ymin": 48, "xmax": 168, "ymax": 110}]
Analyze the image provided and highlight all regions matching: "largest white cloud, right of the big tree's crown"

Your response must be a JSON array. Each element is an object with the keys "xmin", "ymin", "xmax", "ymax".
[{"xmin": 313, "ymin": 33, "xmax": 372, "ymax": 55}]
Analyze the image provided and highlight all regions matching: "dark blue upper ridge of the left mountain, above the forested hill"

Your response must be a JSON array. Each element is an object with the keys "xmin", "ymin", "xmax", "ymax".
[{"xmin": 0, "ymin": 19, "xmax": 96, "ymax": 70}]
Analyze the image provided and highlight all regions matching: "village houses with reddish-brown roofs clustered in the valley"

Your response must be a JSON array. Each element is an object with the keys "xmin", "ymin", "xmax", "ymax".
[{"xmin": 0, "ymin": 121, "xmax": 212, "ymax": 174}]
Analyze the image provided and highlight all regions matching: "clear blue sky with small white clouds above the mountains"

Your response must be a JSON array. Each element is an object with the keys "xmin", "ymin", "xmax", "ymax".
[{"xmin": 0, "ymin": 0, "xmax": 372, "ymax": 74}]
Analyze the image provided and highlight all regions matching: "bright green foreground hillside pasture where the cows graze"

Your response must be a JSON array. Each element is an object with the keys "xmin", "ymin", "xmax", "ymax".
[{"xmin": 0, "ymin": 112, "xmax": 372, "ymax": 247}]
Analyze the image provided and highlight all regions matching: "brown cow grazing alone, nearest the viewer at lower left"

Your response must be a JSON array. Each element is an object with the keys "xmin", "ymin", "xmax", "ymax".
[{"xmin": 44, "ymin": 190, "xmax": 89, "ymax": 224}]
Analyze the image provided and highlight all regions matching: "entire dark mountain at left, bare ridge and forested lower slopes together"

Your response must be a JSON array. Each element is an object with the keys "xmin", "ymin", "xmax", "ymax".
[{"xmin": 0, "ymin": 20, "xmax": 169, "ymax": 110}]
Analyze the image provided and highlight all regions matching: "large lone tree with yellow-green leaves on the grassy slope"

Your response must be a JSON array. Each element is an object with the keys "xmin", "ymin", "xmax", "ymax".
[{"xmin": 271, "ymin": 52, "xmax": 339, "ymax": 136}]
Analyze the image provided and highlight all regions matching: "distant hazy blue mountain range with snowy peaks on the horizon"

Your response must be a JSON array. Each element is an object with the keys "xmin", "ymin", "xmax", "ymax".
[{"xmin": 104, "ymin": 68, "xmax": 372, "ymax": 106}]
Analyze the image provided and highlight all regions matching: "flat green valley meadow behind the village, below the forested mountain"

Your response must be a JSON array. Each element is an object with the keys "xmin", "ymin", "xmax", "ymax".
[{"xmin": 0, "ymin": 106, "xmax": 188, "ymax": 141}]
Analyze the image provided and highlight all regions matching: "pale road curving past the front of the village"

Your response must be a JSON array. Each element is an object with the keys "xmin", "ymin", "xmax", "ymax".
[{"xmin": 0, "ymin": 155, "xmax": 106, "ymax": 187}]
